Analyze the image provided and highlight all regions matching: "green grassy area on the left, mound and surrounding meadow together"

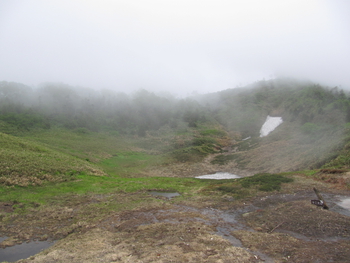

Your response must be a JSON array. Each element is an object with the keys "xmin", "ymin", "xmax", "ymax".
[{"xmin": 0, "ymin": 129, "xmax": 215, "ymax": 207}]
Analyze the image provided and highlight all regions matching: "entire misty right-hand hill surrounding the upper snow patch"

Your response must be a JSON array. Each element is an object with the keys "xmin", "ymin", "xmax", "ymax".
[{"xmin": 194, "ymin": 79, "xmax": 350, "ymax": 173}]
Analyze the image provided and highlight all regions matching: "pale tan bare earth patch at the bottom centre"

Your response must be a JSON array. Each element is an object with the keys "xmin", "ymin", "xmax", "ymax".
[{"xmin": 15, "ymin": 204, "xmax": 262, "ymax": 263}]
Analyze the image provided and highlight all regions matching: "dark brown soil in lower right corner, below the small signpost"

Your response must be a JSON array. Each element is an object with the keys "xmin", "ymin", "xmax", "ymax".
[{"xmin": 232, "ymin": 192, "xmax": 350, "ymax": 262}]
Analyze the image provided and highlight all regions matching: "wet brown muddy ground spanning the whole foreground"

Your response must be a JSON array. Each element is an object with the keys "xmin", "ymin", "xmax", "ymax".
[{"xmin": 0, "ymin": 176, "xmax": 350, "ymax": 263}]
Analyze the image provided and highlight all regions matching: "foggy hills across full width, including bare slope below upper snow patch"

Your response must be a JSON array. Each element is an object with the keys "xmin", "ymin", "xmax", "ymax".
[{"xmin": 0, "ymin": 78, "xmax": 350, "ymax": 172}]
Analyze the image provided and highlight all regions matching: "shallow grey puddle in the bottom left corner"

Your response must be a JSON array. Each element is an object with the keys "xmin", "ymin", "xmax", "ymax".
[{"xmin": 0, "ymin": 238, "xmax": 54, "ymax": 262}]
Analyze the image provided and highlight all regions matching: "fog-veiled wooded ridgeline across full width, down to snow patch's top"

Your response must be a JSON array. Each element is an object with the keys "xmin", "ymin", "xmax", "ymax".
[{"xmin": 0, "ymin": 79, "xmax": 350, "ymax": 138}]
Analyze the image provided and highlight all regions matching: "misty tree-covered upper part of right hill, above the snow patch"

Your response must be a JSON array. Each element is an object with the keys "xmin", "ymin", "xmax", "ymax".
[{"xmin": 197, "ymin": 79, "xmax": 350, "ymax": 138}]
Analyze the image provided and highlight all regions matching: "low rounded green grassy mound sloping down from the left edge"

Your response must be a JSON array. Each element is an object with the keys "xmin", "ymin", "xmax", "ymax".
[{"xmin": 0, "ymin": 133, "xmax": 105, "ymax": 186}]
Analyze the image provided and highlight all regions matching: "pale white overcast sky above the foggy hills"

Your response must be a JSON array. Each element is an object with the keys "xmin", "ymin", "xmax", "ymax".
[{"xmin": 0, "ymin": 0, "xmax": 350, "ymax": 95}]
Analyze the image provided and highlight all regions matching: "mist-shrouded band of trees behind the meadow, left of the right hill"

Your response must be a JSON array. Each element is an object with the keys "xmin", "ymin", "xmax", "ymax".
[{"xmin": 0, "ymin": 81, "xmax": 208, "ymax": 136}]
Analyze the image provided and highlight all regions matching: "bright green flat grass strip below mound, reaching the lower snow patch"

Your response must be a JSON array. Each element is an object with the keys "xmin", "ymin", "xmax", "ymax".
[{"xmin": 0, "ymin": 174, "xmax": 208, "ymax": 204}]
